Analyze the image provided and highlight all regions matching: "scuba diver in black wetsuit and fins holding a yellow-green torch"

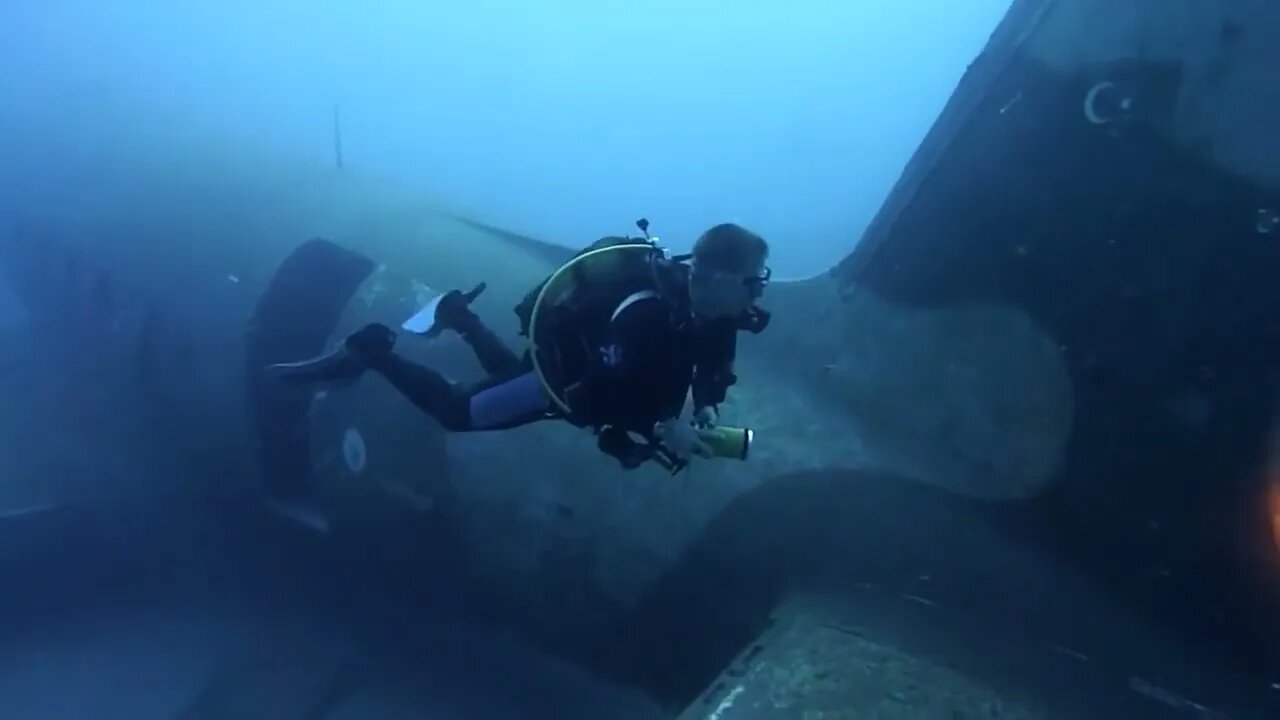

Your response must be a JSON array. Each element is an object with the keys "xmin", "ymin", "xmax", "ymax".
[{"xmin": 268, "ymin": 219, "xmax": 771, "ymax": 473}]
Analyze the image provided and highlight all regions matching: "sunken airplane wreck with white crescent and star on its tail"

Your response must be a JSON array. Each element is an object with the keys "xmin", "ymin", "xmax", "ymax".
[{"xmin": 0, "ymin": 0, "xmax": 1280, "ymax": 720}]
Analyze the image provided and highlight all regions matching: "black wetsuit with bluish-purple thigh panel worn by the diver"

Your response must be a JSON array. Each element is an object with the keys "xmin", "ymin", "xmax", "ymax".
[{"xmin": 367, "ymin": 257, "xmax": 740, "ymax": 466}]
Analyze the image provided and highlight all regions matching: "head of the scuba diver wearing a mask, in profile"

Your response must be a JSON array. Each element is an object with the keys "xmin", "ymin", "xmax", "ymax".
[{"xmin": 689, "ymin": 223, "xmax": 769, "ymax": 319}]
